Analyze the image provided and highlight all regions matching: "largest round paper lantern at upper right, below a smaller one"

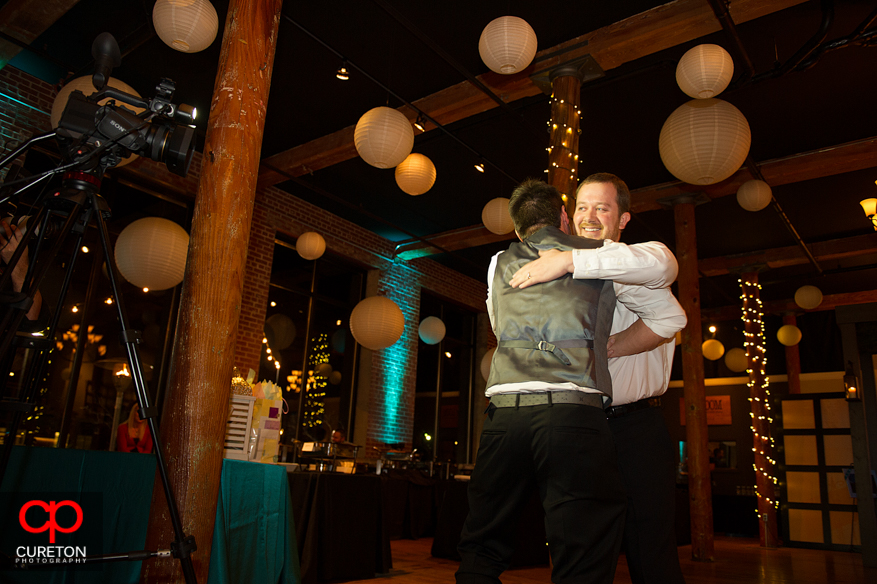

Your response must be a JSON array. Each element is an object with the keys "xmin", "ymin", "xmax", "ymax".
[{"xmin": 658, "ymin": 98, "xmax": 752, "ymax": 185}]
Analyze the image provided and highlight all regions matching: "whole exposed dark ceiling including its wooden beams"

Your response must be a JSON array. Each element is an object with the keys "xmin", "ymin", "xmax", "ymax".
[{"xmin": 0, "ymin": 0, "xmax": 877, "ymax": 318}]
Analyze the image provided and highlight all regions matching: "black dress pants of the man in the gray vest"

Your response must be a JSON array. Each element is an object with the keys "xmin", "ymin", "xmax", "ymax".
[{"xmin": 456, "ymin": 404, "xmax": 627, "ymax": 584}]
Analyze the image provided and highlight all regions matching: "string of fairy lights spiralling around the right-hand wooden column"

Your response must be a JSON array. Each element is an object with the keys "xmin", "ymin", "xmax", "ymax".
[{"xmin": 738, "ymin": 278, "xmax": 779, "ymax": 513}]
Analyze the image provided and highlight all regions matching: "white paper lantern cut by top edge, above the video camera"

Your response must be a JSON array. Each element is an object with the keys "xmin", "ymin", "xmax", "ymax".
[{"xmin": 152, "ymin": 0, "xmax": 219, "ymax": 53}]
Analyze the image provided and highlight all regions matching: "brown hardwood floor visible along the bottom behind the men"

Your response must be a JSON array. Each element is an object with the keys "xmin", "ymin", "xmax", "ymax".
[{"xmin": 346, "ymin": 537, "xmax": 877, "ymax": 584}]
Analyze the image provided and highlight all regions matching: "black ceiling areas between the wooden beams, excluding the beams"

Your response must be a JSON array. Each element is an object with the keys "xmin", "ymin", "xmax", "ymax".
[{"xmin": 0, "ymin": 0, "xmax": 877, "ymax": 308}]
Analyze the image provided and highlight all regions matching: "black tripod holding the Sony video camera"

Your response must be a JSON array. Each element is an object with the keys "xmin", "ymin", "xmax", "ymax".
[{"xmin": 0, "ymin": 132, "xmax": 197, "ymax": 584}]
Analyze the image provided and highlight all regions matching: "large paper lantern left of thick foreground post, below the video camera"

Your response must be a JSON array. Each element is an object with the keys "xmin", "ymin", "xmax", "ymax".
[{"xmin": 115, "ymin": 217, "xmax": 189, "ymax": 290}]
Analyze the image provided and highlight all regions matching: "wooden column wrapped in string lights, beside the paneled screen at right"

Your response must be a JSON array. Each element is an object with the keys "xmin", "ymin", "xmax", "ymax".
[{"xmin": 740, "ymin": 272, "xmax": 779, "ymax": 548}]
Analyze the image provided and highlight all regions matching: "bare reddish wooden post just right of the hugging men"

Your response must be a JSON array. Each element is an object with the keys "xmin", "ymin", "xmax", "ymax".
[{"xmin": 673, "ymin": 199, "xmax": 715, "ymax": 562}]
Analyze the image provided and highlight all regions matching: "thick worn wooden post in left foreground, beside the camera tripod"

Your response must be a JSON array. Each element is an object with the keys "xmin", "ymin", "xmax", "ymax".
[{"xmin": 141, "ymin": 0, "xmax": 282, "ymax": 583}]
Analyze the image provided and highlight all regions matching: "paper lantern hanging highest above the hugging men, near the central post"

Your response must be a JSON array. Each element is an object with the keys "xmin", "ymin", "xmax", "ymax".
[{"xmin": 478, "ymin": 16, "xmax": 536, "ymax": 75}]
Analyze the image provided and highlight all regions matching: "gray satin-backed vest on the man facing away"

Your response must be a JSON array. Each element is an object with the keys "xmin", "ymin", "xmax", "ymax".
[{"xmin": 487, "ymin": 227, "xmax": 615, "ymax": 399}]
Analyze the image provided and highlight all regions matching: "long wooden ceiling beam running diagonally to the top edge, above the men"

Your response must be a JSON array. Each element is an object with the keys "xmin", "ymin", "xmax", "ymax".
[{"xmin": 258, "ymin": 0, "xmax": 805, "ymax": 188}]
